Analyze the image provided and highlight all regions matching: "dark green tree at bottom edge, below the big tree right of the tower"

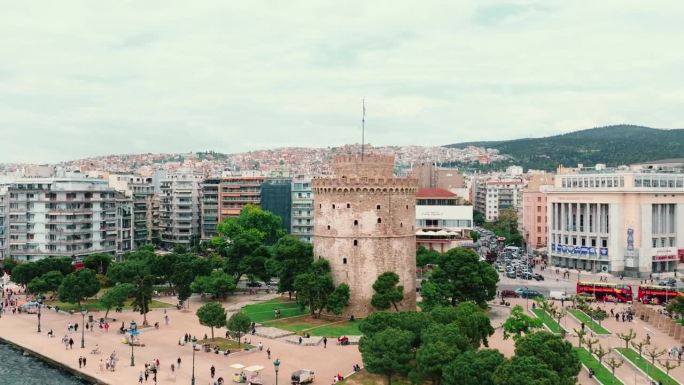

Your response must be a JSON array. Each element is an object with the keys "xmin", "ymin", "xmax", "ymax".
[{"xmin": 442, "ymin": 349, "xmax": 505, "ymax": 385}]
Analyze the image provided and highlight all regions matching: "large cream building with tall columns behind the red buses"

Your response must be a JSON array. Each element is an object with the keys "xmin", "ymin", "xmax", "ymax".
[{"xmin": 547, "ymin": 165, "xmax": 684, "ymax": 276}]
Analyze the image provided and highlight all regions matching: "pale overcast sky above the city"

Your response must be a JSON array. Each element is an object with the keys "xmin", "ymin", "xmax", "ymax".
[{"xmin": 0, "ymin": 0, "xmax": 684, "ymax": 162}]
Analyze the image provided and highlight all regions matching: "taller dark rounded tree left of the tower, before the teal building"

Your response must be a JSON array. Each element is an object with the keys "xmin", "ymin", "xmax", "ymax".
[{"xmin": 273, "ymin": 235, "xmax": 313, "ymax": 298}]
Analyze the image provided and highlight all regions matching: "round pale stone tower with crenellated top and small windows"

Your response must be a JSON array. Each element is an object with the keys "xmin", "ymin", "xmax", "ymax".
[{"xmin": 313, "ymin": 153, "xmax": 417, "ymax": 318}]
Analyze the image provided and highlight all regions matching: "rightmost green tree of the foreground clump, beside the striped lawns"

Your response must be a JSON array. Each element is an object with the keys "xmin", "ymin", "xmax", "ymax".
[{"xmin": 515, "ymin": 332, "xmax": 581, "ymax": 385}]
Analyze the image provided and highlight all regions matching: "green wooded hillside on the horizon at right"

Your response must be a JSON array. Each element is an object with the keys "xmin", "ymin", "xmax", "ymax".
[{"xmin": 446, "ymin": 125, "xmax": 684, "ymax": 170}]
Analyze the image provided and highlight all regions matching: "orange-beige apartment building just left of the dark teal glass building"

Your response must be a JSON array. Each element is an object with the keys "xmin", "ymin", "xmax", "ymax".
[{"xmin": 219, "ymin": 174, "xmax": 266, "ymax": 221}]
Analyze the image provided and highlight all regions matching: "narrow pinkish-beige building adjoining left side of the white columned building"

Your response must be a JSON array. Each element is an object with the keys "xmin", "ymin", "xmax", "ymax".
[{"xmin": 518, "ymin": 173, "xmax": 554, "ymax": 251}]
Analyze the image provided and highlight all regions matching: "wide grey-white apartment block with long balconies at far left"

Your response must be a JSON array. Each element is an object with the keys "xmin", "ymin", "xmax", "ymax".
[{"xmin": 0, "ymin": 178, "xmax": 118, "ymax": 261}]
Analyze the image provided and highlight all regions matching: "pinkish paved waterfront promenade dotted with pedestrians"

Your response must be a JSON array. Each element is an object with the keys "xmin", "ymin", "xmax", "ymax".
[{"xmin": 0, "ymin": 295, "xmax": 361, "ymax": 385}]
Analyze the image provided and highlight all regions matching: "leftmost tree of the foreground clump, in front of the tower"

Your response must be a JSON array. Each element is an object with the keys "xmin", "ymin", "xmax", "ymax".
[{"xmin": 359, "ymin": 328, "xmax": 414, "ymax": 385}]
